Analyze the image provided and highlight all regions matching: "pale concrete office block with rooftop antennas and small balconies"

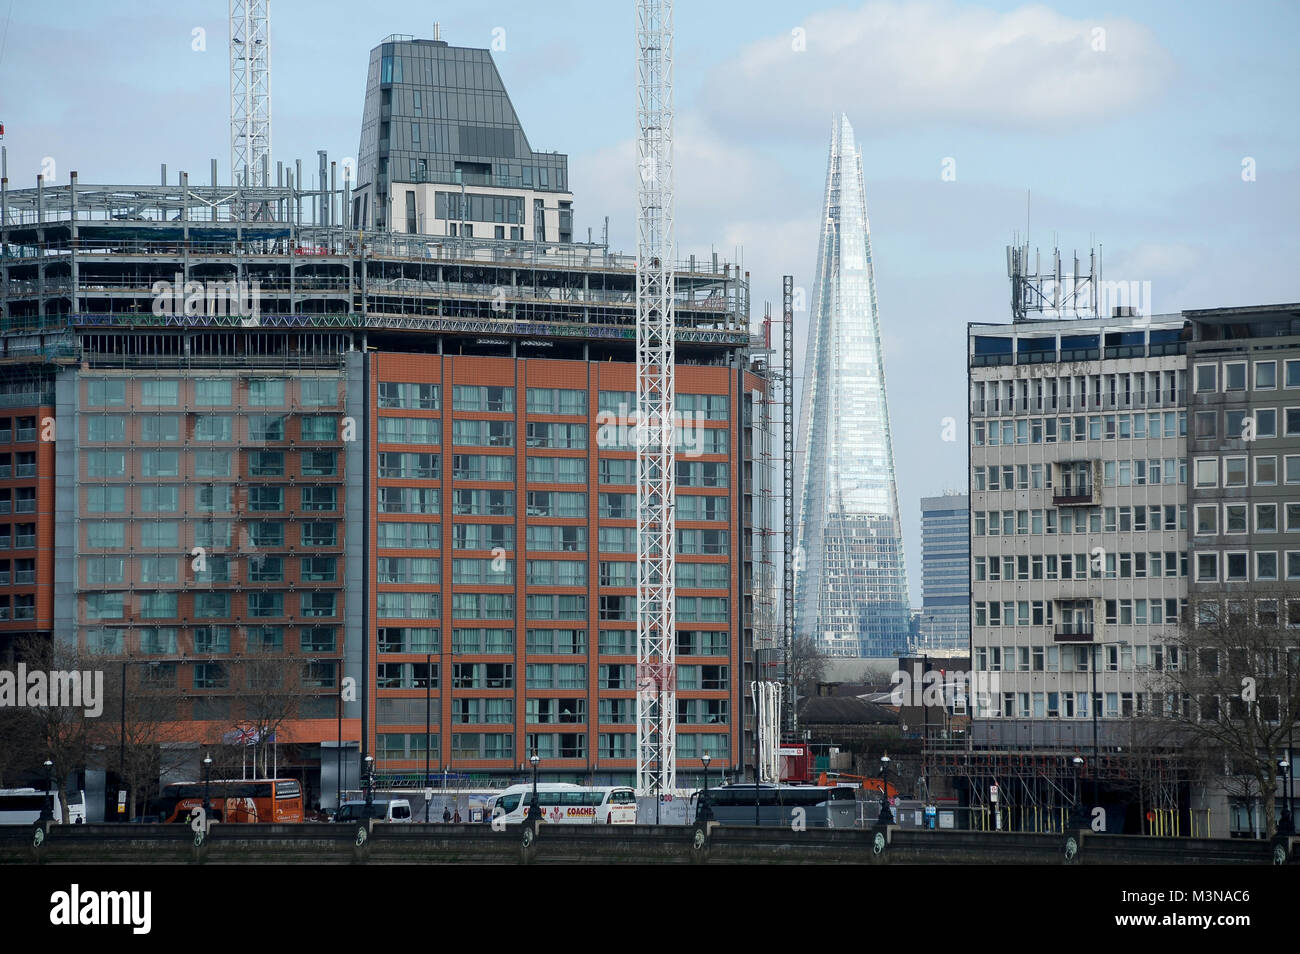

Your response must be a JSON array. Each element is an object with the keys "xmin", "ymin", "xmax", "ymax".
[{"xmin": 970, "ymin": 316, "xmax": 1187, "ymax": 749}]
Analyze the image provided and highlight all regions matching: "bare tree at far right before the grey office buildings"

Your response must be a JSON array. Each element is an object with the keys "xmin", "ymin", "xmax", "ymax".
[{"xmin": 1157, "ymin": 594, "xmax": 1300, "ymax": 838}]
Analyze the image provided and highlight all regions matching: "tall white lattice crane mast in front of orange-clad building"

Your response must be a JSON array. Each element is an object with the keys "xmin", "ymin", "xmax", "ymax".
[{"xmin": 637, "ymin": 0, "xmax": 677, "ymax": 815}]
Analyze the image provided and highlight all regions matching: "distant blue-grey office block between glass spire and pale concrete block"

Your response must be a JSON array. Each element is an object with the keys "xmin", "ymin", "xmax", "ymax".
[{"xmin": 917, "ymin": 491, "xmax": 971, "ymax": 652}]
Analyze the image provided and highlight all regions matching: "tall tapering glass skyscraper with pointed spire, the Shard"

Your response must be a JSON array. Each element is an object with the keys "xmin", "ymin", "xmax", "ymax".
[{"xmin": 794, "ymin": 114, "xmax": 909, "ymax": 656}]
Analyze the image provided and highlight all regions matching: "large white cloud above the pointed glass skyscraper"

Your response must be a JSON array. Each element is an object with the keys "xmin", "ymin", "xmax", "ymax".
[{"xmin": 701, "ymin": 1, "xmax": 1173, "ymax": 136}]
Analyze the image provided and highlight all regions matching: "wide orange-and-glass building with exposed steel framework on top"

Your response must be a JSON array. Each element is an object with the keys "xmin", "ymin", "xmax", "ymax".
[{"xmin": 0, "ymin": 24, "xmax": 776, "ymax": 814}]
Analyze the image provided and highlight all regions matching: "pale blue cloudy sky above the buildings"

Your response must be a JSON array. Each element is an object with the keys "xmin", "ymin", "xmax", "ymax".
[{"xmin": 0, "ymin": 0, "xmax": 1300, "ymax": 597}]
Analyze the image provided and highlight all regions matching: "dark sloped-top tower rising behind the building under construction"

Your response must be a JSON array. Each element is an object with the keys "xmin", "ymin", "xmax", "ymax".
[{"xmin": 352, "ymin": 35, "xmax": 573, "ymax": 242}]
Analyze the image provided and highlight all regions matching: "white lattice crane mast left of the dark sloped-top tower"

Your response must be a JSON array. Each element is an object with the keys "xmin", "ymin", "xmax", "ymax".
[{"xmin": 230, "ymin": 0, "xmax": 270, "ymax": 188}]
